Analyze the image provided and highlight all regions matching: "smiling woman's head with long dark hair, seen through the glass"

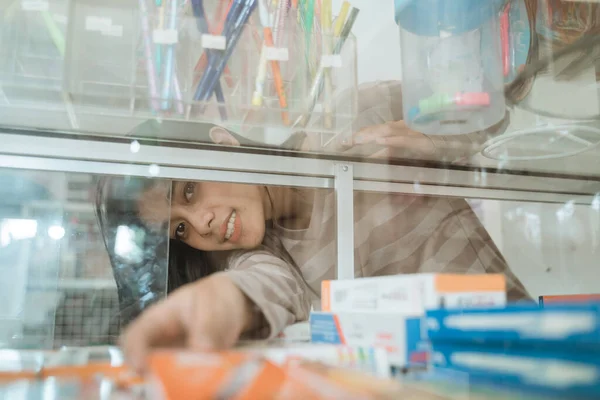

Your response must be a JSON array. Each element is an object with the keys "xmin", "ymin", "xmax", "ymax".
[{"xmin": 96, "ymin": 121, "xmax": 310, "ymax": 326}]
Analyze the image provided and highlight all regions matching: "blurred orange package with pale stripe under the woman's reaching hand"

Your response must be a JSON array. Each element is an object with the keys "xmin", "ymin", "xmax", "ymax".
[{"xmin": 149, "ymin": 351, "xmax": 285, "ymax": 400}]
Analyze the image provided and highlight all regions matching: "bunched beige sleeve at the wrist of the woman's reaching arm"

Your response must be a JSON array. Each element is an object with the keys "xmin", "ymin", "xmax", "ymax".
[{"xmin": 224, "ymin": 250, "xmax": 310, "ymax": 339}]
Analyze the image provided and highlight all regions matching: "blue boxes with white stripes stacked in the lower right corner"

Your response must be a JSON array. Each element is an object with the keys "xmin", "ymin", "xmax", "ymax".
[{"xmin": 427, "ymin": 304, "xmax": 600, "ymax": 399}]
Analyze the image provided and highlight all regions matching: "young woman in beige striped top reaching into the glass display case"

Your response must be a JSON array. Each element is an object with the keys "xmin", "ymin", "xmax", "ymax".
[{"xmin": 100, "ymin": 83, "xmax": 528, "ymax": 367}]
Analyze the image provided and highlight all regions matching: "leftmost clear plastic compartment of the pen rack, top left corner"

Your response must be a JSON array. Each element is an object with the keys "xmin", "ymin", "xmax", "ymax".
[{"xmin": 0, "ymin": 0, "xmax": 68, "ymax": 106}]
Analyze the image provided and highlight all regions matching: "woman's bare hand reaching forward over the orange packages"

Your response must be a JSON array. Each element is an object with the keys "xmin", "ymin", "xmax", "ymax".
[{"xmin": 122, "ymin": 274, "xmax": 254, "ymax": 371}]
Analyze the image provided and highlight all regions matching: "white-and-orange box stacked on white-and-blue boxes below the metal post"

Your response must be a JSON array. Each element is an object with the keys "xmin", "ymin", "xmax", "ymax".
[{"xmin": 310, "ymin": 274, "xmax": 506, "ymax": 367}]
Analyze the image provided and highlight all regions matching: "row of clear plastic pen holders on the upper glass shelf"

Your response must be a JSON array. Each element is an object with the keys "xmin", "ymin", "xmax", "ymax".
[{"xmin": 0, "ymin": 0, "xmax": 357, "ymax": 144}]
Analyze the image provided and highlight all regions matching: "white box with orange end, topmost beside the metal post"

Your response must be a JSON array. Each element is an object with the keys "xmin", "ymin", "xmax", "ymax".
[{"xmin": 321, "ymin": 274, "xmax": 506, "ymax": 315}]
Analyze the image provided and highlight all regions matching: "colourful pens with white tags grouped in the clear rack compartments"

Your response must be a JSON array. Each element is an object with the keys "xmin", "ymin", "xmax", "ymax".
[{"xmin": 138, "ymin": 0, "xmax": 359, "ymax": 129}]
